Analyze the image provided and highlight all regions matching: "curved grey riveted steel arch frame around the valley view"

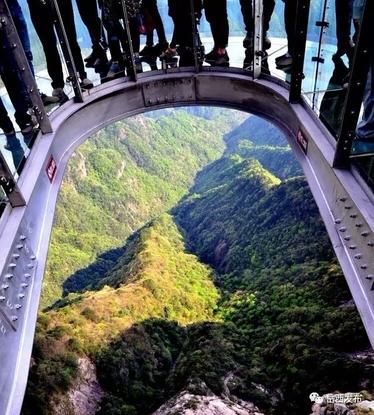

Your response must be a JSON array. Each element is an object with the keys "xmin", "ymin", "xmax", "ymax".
[{"xmin": 0, "ymin": 68, "xmax": 374, "ymax": 415}]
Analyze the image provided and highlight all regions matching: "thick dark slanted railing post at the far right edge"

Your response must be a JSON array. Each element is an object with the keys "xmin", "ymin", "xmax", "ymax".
[{"xmin": 334, "ymin": 0, "xmax": 374, "ymax": 168}]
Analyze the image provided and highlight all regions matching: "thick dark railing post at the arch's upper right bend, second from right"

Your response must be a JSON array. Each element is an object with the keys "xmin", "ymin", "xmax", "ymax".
[{"xmin": 289, "ymin": 0, "xmax": 310, "ymax": 103}]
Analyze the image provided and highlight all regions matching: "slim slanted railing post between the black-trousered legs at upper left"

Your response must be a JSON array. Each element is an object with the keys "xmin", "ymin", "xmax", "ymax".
[{"xmin": 50, "ymin": 0, "xmax": 83, "ymax": 102}]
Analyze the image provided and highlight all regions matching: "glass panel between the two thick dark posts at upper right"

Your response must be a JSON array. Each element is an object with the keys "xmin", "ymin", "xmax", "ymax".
[{"xmin": 303, "ymin": 0, "xmax": 357, "ymax": 134}]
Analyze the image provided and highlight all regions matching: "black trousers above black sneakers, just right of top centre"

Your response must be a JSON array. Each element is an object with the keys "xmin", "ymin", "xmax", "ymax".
[{"xmin": 203, "ymin": 0, "xmax": 229, "ymax": 49}]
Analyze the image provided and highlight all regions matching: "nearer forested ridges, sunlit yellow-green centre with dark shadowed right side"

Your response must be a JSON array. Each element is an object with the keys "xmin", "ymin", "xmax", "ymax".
[{"xmin": 24, "ymin": 114, "xmax": 374, "ymax": 415}]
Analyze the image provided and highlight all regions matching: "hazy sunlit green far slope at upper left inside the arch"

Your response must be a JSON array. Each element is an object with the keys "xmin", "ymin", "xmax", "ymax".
[{"xmin": 42, "ymin": 110, "xmax": 244, "ymax": 307}]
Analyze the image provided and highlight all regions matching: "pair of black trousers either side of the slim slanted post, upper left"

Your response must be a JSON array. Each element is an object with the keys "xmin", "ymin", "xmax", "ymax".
[{"xmin": 27, "ymin": 0, "xmax": 87, "ymax": 88}]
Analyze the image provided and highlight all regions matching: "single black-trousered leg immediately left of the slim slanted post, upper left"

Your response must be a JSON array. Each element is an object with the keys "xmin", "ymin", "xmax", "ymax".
[{"xmin": 28, "ymin": 0, "xmax": 65, "ymax": 89}]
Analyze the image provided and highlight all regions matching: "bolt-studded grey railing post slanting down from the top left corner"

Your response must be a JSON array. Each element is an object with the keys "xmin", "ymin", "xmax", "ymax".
[{"xmin": 0, "ymin": 0, "xmax": 52, "ymax": 133}]
